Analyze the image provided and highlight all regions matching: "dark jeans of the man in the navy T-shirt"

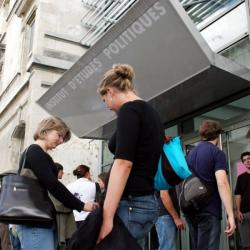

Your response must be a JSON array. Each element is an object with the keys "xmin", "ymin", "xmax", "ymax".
[{"xmin": 185, "ymin": 213, "xmax": 221, "ymax": 250}]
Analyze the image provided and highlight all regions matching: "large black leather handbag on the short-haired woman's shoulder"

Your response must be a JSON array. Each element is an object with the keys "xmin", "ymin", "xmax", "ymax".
[{"xmin": 0, "ymin": 149, "xmax": 55, "ymax": 227}]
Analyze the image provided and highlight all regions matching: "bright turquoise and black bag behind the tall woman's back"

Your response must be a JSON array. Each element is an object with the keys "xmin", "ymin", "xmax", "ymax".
[{"xmin": 154, "ymin": 136, "xmax": 192, "ymax": 190}]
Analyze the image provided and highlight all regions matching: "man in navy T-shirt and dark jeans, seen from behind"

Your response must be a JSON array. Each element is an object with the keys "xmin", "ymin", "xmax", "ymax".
[{"xmin": 185, "ymin": 120, "xmax": 235, "ymax": 250}]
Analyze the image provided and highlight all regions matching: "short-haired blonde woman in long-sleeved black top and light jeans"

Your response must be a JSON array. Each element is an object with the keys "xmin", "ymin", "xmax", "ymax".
[{"xmin": 14, "ymin": 117, "xmax": 97, "ymax": 250}]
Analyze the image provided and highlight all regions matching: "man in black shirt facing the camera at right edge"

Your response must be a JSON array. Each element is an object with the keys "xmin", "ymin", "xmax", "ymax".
[{"xmin": 234, "ymin": 152, "xmax": 250, "ymax": 250}]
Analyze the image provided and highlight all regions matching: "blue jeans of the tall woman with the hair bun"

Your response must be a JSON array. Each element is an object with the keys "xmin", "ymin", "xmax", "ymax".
[{"xmin": 117, "ymin": 195, "xmax": 159, "ymax": 240}]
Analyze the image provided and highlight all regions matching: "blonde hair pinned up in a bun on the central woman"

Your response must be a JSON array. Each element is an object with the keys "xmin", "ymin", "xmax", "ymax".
[{"xmin": 97, "ymin": 64, "xmax": 135, "ymax": 96}]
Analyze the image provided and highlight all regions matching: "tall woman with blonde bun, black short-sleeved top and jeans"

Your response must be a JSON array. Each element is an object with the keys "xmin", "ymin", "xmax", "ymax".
[{"xmin": 98, "ymin": 64, "xmax": 164, "ymax": 248}]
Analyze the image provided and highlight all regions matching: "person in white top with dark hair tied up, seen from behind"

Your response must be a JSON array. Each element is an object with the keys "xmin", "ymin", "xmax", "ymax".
[{"xmin": 67, "ymin": 165, "xmax": 96, "ymax": 227}]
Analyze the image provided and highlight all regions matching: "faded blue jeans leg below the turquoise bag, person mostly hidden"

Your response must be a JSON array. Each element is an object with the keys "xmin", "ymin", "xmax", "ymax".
[{"xmin": 155, "ymin": 214, "xmax": 177, "ymax": 250}]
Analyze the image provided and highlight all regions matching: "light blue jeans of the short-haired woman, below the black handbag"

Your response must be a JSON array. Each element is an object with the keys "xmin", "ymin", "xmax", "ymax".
[{"xmin": 16, "ymin": 225, "xmax": 57, "ymax": 250}]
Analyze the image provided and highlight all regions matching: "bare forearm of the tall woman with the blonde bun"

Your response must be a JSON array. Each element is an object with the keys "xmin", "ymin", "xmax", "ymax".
[{"xmin": 103, "ymin": 159, "xmax": 132, "ymax": 220}]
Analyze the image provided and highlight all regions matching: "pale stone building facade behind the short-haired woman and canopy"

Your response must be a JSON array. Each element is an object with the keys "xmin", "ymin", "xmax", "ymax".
[{"xmin": 0, "ymin": 0, "xmax": 102, "ymax": 182}]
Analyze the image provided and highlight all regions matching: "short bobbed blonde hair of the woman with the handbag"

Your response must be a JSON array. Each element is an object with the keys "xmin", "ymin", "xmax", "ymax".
[{"xmin": 33, "ymin": 117, "xmax": 71, "ymax": 142}]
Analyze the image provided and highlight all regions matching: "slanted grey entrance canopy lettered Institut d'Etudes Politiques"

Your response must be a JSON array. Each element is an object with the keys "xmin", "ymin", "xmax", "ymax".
[{"xmin": 38, "ymin": 0, "xmax": 250, "ymax": 139}]
